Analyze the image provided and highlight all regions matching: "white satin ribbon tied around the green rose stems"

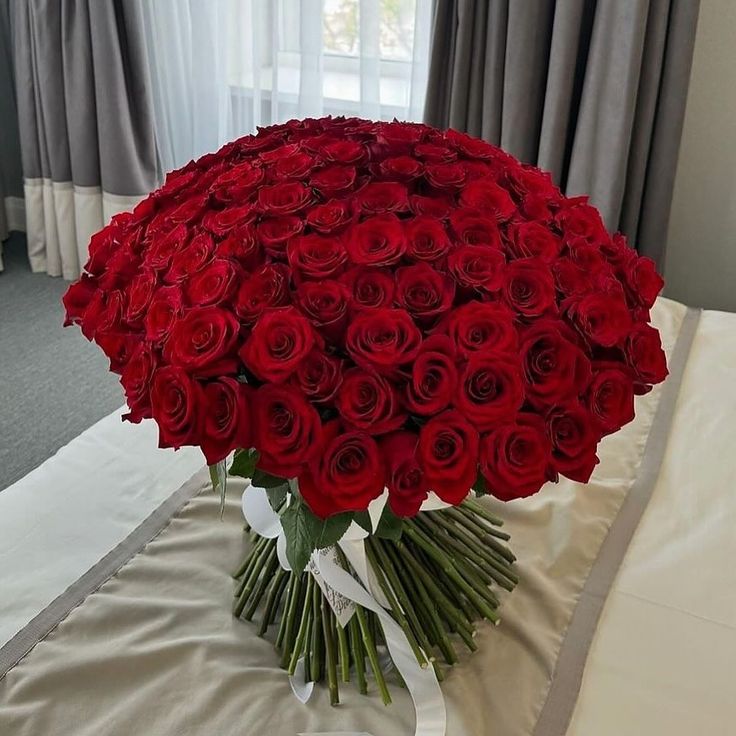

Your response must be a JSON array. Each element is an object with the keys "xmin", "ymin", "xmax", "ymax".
[{"xmin": 242, "ymin": 486, "xmax": 447, "ymax": 736}]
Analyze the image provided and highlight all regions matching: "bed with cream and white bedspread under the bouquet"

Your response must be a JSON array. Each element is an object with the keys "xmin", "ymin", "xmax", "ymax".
[{"xmin": 0, "ymin": 299, "xmax": 736, "ymax": 736}]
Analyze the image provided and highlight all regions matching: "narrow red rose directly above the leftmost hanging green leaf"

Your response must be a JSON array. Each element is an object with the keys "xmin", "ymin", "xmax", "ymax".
[{"xmin": 201, "ymin": 378, "xmax": 253, "ymax": 465}]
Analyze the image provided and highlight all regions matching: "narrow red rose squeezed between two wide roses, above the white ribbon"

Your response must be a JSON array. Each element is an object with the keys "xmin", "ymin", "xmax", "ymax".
[{"xmin": 379, "ymin": 431, "xmax": 429, "ymax": 516}]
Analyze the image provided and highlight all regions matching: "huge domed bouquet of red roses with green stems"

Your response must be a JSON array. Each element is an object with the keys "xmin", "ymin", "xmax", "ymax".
[{"xmin": 64, "ymin": 118, "xmax": 667, "ymax": 699}]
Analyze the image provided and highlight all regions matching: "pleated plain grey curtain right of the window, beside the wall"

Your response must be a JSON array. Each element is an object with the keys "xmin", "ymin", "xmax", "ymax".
[{"xmin": 425, "ymin": 0, "xmax": 699, "ymax": 265}]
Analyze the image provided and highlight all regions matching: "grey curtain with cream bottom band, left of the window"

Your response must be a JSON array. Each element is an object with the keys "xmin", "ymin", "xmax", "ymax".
[{"xmin": 11, "ymin": 0, "xmax": 158, "ymax": 279}]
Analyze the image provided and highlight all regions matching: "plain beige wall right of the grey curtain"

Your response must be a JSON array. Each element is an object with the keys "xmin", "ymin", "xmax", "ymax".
[{"xmin": 665, "ymin": 0, "xmax": 736, "ymax": 311}]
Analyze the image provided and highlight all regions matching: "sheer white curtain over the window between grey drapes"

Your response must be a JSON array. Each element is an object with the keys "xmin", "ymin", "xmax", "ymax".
[{"xmin": 140, "ymin": 0, "xmax": 432, "ymax": 171}]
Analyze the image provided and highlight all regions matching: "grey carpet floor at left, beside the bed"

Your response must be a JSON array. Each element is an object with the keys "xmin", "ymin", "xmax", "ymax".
[{"xmin": 0, "ymin": 233, "xmax": 124, "ymax": 491}]
